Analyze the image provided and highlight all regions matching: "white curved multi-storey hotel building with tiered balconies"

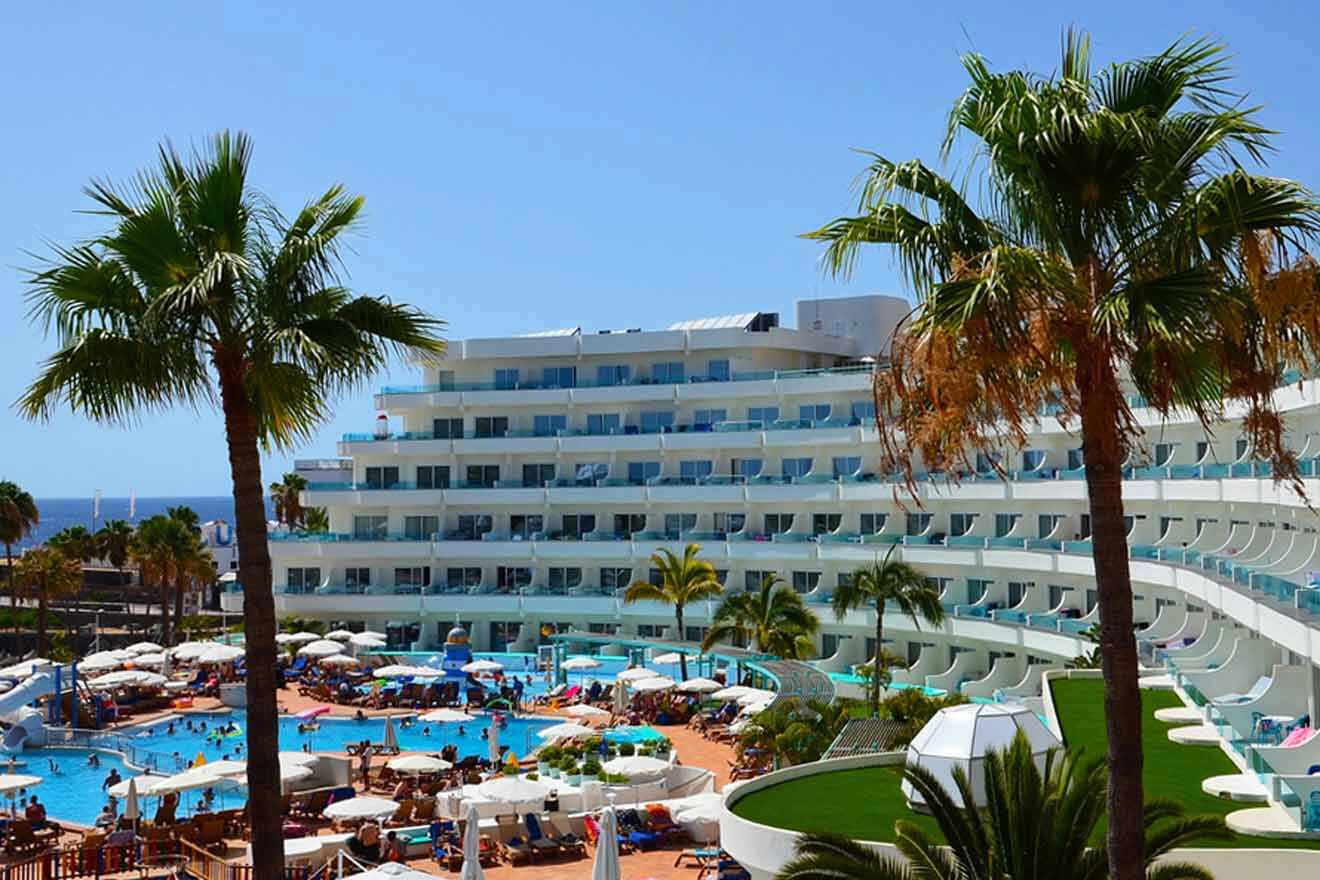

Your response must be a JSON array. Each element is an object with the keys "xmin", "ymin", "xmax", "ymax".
[{"xmin": 224, "ymin": 297, "xmax": 1320, "ymax": 716}]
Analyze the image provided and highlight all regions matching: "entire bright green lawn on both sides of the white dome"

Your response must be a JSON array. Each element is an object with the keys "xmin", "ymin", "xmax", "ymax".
[{"xmin": 734, "ymin": 679, "xmax": 1320, "ymax": 848}]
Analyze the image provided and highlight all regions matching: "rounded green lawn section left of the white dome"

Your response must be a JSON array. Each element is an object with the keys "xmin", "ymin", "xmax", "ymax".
[{"xmin": 734, "ymin": 764, "xmax": 940, "ymax": 840}]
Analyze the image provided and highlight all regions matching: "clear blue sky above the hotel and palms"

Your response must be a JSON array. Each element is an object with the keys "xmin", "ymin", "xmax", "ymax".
[{"xmin": 0, "ymin": 1, "xmax": 1320, "ymax": 496}]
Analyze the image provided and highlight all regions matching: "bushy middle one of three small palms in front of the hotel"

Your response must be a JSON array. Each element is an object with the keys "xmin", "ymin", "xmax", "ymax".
[{"xmin": 701, "ymin": 573, "xmax": 821, "ymax": 660}]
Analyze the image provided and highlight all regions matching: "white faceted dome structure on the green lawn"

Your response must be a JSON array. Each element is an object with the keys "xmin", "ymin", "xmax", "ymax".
[{"xmin": 903, "ymin": 703, "xmax": 1063, "ymax": 806}]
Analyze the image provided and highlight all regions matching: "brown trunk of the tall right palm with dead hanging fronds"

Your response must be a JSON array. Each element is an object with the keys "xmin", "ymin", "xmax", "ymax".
[{"xmin": 1077, "ymin": 356, "xmax": 1146, "ymax": 880}]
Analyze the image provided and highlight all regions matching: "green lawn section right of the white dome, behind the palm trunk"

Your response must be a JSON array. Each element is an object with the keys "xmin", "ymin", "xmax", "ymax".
[{"xmin": 1051, "ymin": 678, "xmax": 1320, "ymax": 850}]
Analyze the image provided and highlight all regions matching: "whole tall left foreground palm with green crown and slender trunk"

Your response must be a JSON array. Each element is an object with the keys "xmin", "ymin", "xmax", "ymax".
[{"xmin": 20, "ymin": 133, "xmax": 444, "ymax": 880}]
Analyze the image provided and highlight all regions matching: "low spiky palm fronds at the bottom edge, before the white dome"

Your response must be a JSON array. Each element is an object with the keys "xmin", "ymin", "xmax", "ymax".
[{"xmin": 775, "ymin": 732, "xmax": 1232, "ymax": 880}]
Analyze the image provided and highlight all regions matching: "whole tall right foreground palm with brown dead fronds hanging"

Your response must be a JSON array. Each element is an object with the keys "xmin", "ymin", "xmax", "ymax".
[{"xmin": 809, "ymin": 32, "xmax": 1320, "ymax": 880}]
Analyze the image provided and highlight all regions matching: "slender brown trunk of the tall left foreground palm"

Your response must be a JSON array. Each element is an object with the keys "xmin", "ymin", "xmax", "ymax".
[{"xmin": 218, "ymin": 363, "xmax": 284, "ymax": 880}]
